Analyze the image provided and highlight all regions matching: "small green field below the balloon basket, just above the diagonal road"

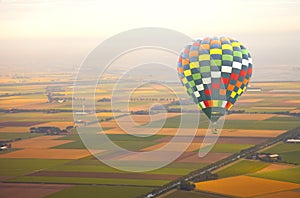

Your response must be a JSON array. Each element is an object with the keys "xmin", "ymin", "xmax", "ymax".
[{"xmin": 197, "ymin": 144, "xmax": 253, "ymax": 153}]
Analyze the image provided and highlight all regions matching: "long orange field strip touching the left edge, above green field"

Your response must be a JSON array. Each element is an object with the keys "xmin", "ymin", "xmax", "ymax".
[{"xmin": 0, "ymin": 148, "xmax": 91, "ymax": 159}]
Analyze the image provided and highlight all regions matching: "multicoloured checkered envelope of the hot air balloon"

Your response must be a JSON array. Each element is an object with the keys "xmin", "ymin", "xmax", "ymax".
[{"xmin": 177, "ymin": 37, "xmax": 252, "ymax": 122}]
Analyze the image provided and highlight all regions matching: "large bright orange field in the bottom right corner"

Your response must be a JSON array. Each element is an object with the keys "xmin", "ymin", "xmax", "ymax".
[{"xmin": 196, "ymin": 176, "xmax": 300, "ymax": 197}]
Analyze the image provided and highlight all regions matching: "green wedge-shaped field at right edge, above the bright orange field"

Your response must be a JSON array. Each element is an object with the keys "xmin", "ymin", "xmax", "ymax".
[{"xmin": 251, "ymin": 167, "xmax": 300, "ymax": 184}]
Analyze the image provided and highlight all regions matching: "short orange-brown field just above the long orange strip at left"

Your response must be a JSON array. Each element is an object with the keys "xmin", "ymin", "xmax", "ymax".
[{"xmin": 12, "ymin": 136, "xmax": 72, "ymax": 149}]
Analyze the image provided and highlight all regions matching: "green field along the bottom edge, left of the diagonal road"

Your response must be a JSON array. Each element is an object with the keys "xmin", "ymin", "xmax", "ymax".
[{"xmin": 47, "ymin": 186, "xmax": 152, "ymax": 198}]
